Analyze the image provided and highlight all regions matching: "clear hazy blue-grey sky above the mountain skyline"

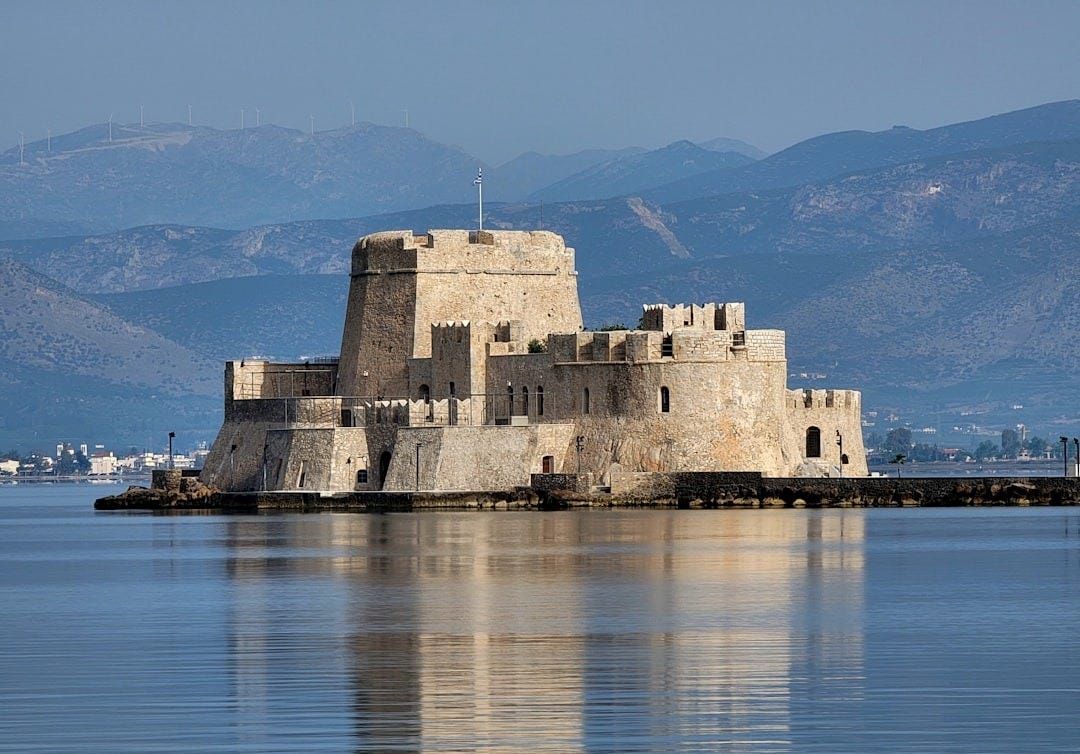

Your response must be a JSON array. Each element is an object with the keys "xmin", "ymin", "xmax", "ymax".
[{"xmin": 0, "ymin": 0, "xmax": 1080, "ymax": 164}]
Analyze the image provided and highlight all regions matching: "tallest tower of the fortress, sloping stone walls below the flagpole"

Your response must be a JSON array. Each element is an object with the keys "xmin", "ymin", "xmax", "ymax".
[{"xmin": 337, "ymin": 230, "xmax": 582, "ymax": 395}]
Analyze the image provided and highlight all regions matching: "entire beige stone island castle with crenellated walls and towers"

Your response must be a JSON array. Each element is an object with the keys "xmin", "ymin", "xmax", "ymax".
[{"xmin": 202, "ymin": 230, "xmax": 867, "ymax": 493}]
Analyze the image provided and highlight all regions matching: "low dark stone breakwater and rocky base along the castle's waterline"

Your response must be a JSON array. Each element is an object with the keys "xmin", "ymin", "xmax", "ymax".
[{"xmin": 95, "ymin": 472, "xmax": 1080, "ymax": 513}]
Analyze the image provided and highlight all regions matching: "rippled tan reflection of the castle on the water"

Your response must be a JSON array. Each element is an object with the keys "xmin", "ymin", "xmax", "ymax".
[{"xmin": 223, "ymin": 511, "xmax": 864, "ymax": 751}]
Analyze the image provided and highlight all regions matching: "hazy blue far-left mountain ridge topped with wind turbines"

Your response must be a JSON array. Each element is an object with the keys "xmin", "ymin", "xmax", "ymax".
[{"xmin": 0, "ymin": 123, "xmax": 478, "ymax": 232}]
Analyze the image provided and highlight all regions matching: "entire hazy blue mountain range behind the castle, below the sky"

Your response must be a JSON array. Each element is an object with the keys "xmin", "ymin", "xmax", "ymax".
[{"xmin": 0, "ymin": 102, "xmax": 1080, "ymax": 445}]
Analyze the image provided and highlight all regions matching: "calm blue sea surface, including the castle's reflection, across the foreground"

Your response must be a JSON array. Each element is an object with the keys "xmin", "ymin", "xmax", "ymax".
[{"xmin": 0, "ymin": 485, "xmax": 1080, "ymax": 754}]
